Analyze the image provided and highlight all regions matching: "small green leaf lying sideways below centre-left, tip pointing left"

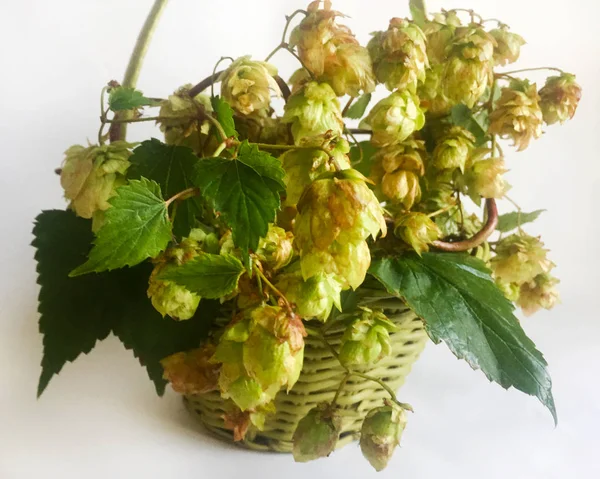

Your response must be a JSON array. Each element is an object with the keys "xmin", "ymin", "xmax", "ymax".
[{"xmin": 158, "ymin": 253, "xmax": 245, "ymax": 299}]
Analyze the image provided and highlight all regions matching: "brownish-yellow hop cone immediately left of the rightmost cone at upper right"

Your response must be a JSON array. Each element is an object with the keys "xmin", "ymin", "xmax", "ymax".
[{"xmin": 489, "ymin": 81, "xmax": 543, "ymax": 151}]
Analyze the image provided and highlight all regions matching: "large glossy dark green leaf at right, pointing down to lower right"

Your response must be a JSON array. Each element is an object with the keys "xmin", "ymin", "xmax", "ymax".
[{"xmin": 369, "ymin": 253, "xmax": 557, "ymax": 423}]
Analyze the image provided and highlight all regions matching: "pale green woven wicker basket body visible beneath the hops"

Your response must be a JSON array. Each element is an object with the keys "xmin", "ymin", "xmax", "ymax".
[{"xmin": 184, "ymin": 309, "xmax": 428, "ymax": 452}]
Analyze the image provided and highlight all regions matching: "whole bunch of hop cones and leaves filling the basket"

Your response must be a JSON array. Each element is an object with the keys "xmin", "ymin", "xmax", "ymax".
[{"xmin": 34, "ymin": 0, "xmax": 581, "ymax": 470}]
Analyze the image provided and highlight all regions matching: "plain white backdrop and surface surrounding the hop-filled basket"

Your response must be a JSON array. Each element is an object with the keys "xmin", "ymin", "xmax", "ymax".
[{"xmin": 0, "ymin": 0, "xmax": 600, "ymax": 479}]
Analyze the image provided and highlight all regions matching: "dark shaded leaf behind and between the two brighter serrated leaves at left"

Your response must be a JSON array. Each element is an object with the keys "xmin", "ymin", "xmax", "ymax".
[{"xmin": 127, "ymin": 138, "xmax": 201, "ymax": 238}]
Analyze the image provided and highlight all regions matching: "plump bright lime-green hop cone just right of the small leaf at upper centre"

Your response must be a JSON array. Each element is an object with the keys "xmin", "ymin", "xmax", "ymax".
[{"xmin": 362, "ymin": 90, "xmax": 425, "ymax": 147}]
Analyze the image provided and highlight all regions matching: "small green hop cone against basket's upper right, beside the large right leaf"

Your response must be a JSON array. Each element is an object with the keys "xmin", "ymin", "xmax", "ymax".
[{"xmin": 339, "ymin": 308, "xmax": 396, "ymax": 367}]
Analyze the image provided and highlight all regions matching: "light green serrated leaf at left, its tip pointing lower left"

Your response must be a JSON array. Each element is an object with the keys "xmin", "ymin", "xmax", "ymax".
[{"xmin": 70, "ymin": 178, "xmax": 171, "ymax": 276}]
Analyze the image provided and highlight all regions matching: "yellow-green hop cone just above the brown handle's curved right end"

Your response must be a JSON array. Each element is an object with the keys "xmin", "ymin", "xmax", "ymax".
[{"xmin": 464, "ymin": 150, "xmax": 510, "ymax": 203}]
